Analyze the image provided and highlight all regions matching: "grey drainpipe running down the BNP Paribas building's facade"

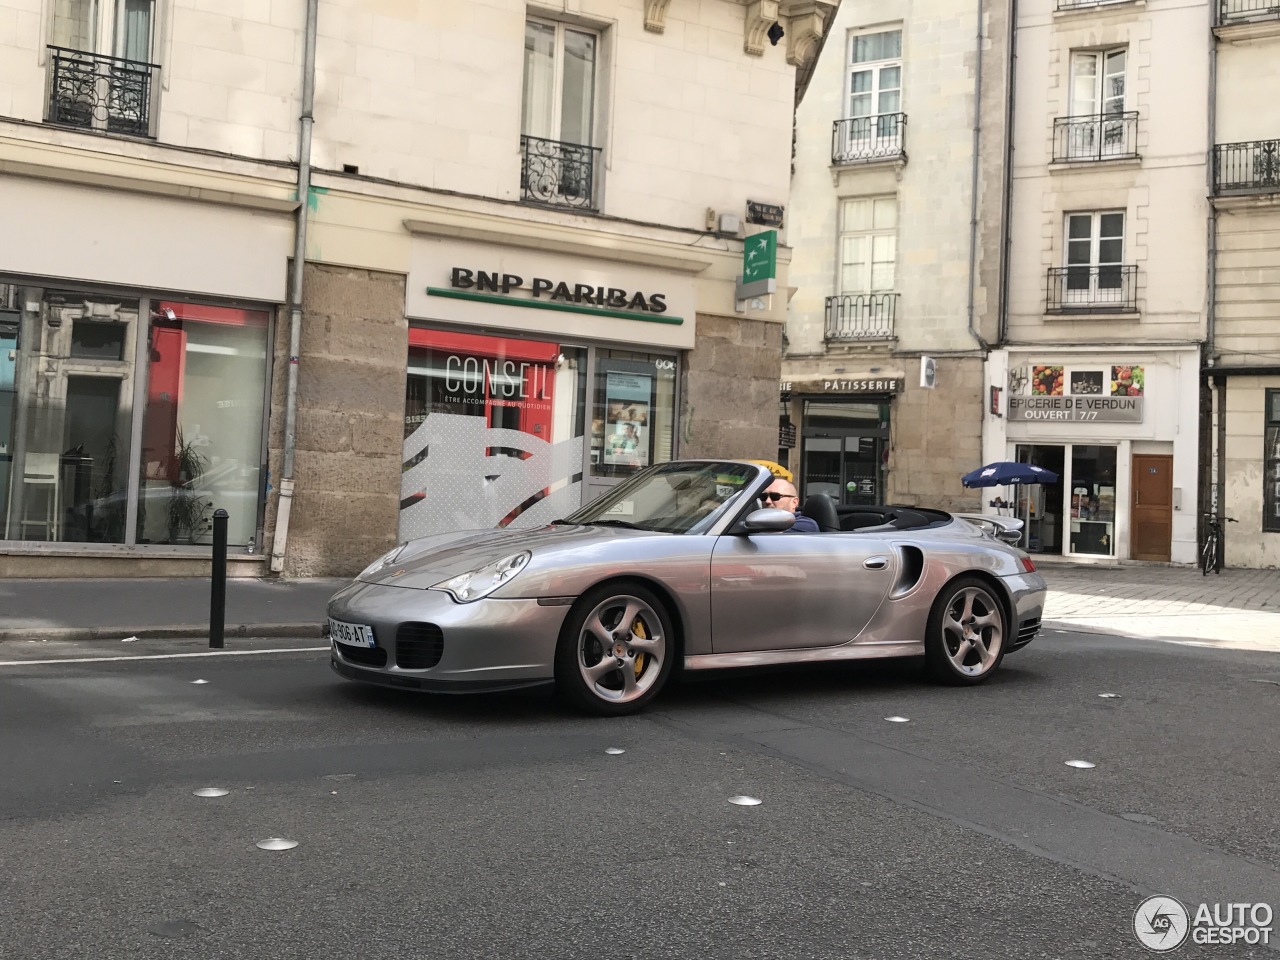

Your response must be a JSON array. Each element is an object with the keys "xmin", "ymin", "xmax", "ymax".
[{"xmin": 271, "ymin": 0, "xmax": 320, "ymax": 573}]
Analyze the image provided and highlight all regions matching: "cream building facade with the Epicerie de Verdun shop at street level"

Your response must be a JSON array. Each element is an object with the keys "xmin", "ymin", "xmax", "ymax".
[{"xmin": 983, "ymin": 0, "xmax": 1210, "ymax": 563}]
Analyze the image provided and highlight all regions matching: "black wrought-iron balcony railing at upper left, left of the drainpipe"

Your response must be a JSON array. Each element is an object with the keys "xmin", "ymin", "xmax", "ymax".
[{"xmin": 45, "ymin": 46, "xmax": 160, "ymax": 137}]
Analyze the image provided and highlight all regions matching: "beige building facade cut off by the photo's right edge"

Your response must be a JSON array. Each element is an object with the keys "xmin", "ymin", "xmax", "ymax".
[{"xmin": 1203, "ymin": 0, "xmax": 1280, "ymax": 567}]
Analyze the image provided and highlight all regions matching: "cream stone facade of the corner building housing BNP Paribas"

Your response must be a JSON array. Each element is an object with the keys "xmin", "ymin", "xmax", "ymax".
[{"xmin": 0, "ymin": 0, "xmax": 836, "ymax": 576}]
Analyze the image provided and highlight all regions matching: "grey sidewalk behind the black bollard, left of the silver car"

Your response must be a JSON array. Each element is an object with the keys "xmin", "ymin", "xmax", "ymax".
[{"xmin": 0, "ymin": 577, "xmax": 351, "ymax": 643}]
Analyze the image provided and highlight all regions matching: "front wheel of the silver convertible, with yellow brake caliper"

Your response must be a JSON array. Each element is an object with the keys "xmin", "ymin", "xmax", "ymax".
[{"xmin": 556, "ymin": 582, "xmax": 675, "ymax": 716}]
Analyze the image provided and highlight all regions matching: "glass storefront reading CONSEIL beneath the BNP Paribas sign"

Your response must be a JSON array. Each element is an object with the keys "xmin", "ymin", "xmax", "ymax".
[{"xmin": 399, "ymin": 328, "xmax": 676, "ymax": 540}]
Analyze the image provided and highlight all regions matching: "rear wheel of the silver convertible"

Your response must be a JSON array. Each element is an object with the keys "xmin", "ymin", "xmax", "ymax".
[{"xmin": 924, "ymin": 577, "xmax": 1009, "ymax": 685}]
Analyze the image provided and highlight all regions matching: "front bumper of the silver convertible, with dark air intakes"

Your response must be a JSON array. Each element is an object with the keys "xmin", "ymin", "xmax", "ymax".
[{"xmin": 328, "ymin": 582, "xmax": 570, "ymax": 692}]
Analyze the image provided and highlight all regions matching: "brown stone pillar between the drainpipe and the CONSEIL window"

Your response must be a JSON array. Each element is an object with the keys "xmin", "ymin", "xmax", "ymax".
[{"xmin": 264, "ymin": 262, "xmax": 408, "ymax": 577}]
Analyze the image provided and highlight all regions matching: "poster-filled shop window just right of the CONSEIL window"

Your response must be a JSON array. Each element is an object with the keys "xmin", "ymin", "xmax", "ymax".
[{"xmin": 591, "ymin": 349, "xmax": 676, "ymax": 477}]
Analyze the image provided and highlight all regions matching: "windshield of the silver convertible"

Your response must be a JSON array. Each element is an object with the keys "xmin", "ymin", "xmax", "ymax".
[{"xmin": 564, "ymin": 461, "xmax": 764, "ymax": 534}]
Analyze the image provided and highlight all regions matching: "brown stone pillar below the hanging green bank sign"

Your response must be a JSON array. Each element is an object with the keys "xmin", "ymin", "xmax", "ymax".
[{"xmin": 677, "ymin": 314, "xmax": 782, "ymax": 460}]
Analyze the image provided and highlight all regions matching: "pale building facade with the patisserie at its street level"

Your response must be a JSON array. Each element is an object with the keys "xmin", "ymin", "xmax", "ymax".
[{"xmin": 780, "ymin": 0, "xmax": 1009, "ymax": 509}]
